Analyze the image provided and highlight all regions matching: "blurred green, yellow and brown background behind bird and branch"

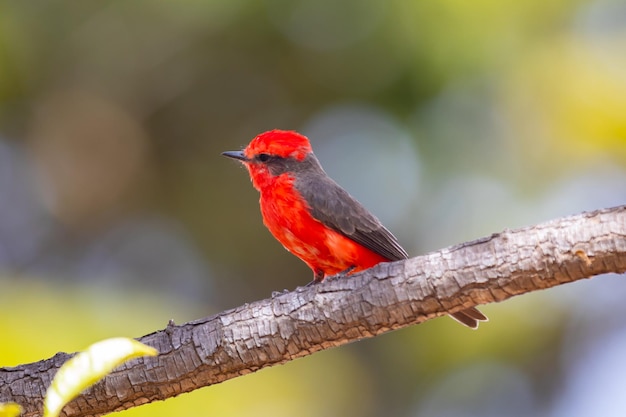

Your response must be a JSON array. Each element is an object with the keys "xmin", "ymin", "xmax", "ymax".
[{"xmin": 0, "ymin": 0, "xmax": 626, "ymax": 417}]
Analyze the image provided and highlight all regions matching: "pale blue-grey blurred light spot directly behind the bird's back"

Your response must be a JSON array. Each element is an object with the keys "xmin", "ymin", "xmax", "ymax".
[{"xmin": 304, "ymin": 105, "xmax": 420, "ymax": 228}]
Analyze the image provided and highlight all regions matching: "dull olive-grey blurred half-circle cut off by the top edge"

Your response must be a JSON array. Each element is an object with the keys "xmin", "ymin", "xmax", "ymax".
[{"xmin": 266, "ymin": 0, "xmax": 386, "ymax": 50}]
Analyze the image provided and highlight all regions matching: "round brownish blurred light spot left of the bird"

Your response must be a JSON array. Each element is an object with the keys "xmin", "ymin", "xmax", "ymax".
[{"xmin": 28, "ymin": 90, "xmax": 152, "ymax": 228}]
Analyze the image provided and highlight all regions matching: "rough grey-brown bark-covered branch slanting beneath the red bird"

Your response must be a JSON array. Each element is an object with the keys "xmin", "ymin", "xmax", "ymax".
[{"xmin": 0, "ymin": 206, "xmax": 626, "ymax": 416}]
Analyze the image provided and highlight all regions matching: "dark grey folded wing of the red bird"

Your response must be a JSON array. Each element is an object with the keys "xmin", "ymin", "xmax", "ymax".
[{"xmin": 295, "ymin": 171, "xmax": 409, "ymax": 261}]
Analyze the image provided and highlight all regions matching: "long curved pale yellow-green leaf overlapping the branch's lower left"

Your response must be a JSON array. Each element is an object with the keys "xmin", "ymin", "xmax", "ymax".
[{"xmin": 43, "ymin": 337, "xmax": 158, "ymax": 417}]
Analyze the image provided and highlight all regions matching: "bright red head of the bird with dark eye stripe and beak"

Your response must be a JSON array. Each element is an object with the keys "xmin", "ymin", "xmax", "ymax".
[{"xmin": 222, "ymin": 130, "xmax": 317, "ymax": 191}]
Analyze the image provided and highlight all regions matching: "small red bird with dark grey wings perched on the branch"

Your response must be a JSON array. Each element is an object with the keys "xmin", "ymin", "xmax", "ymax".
[{"xmin": 222, "ymin": 130, "xmax": 487, "ymax": 329}]
